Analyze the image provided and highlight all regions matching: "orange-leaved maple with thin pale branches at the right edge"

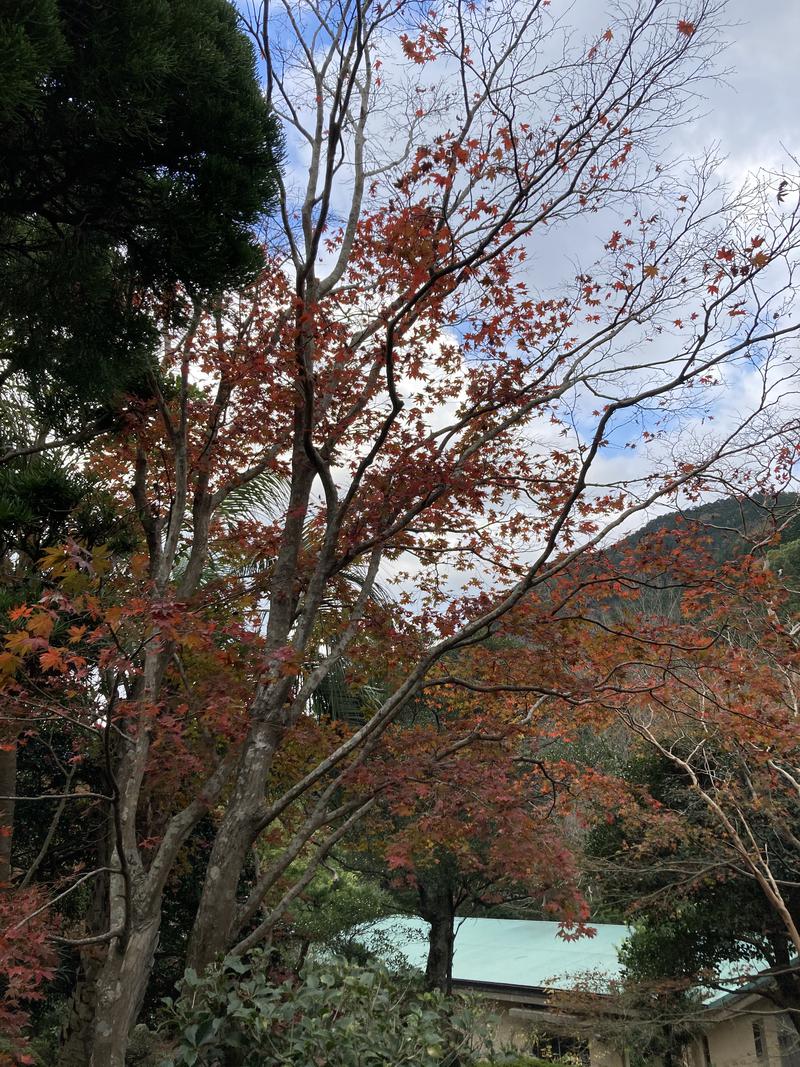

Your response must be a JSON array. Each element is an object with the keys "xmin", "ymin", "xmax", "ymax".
[{"xmin": 623, "ymin": 557, "xmax": 800, "ymax": 1028}]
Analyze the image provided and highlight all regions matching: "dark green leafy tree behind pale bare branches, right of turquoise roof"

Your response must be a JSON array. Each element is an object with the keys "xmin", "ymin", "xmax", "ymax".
[{"xmin": 587, "ymin": 748, "xmax": 798, "ymax": 1042}]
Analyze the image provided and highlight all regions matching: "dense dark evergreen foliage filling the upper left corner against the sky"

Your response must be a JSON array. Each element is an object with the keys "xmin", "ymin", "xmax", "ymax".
[{"xmin": 0, "ymin": 0, "xmax": 279, "ymax": 430}]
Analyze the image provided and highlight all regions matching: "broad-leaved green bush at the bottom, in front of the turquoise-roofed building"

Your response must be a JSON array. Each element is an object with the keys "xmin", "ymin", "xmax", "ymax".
[{"xmin": 164, "ymin": 956, "xmax": 486, "ymax": 1067}]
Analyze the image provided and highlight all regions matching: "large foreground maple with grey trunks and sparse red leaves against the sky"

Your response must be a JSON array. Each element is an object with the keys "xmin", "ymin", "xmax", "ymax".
[{"xmin": 0, "ymin": 0, "xmax": 800, "ymax": 1067}]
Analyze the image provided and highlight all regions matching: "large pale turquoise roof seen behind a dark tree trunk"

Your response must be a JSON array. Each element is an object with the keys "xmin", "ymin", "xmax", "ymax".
[{"xmin": 364, "ymin": 915, "xmax": 628, "ymax": 991}]
